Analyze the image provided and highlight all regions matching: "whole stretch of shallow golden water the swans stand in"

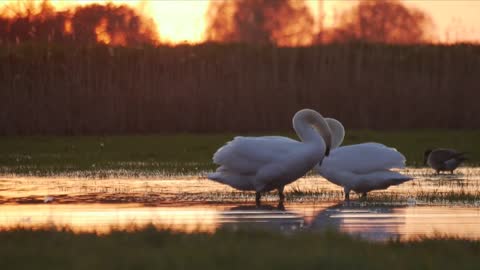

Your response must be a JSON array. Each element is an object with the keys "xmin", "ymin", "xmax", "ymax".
[{"xmin": 0, "ymin": 168, "xmax": 480, "ymax": 240}]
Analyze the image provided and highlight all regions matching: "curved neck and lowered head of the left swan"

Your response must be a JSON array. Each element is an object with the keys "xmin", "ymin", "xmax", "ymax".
[{"xmin": 293, "ymin": 109, "xmax": 332, "ymax": 156}]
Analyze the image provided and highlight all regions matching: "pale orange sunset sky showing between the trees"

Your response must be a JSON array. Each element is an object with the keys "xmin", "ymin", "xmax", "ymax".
[{"xmin": 2, "ymin": 0, "xmax": 480, "ymax": 43}]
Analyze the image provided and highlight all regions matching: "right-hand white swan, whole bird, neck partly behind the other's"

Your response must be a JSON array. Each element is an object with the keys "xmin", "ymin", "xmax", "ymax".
[{"xmin": 315, "ymin": 118, "xmax": 413, "ymax": 201}]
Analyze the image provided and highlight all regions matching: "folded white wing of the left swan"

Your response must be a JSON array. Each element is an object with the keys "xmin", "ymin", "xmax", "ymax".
[{"xmin": 213, "ymin": 136, "xmax": 299, "ymax": 174}]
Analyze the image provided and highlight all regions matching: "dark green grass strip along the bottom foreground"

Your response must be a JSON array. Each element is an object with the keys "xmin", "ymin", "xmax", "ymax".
[{"xmin": 0, "ymin": 228, "xmax": 480, "ymax": 270}]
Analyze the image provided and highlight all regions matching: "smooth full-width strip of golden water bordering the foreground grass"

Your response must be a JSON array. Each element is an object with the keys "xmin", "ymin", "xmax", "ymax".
[{"xmin": 0, "ymin": 203, "xmax": 480, "ymax": 240}]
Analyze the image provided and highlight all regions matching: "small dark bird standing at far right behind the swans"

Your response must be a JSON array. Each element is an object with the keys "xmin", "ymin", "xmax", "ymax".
[{"xmin": 423, "ymin": 148, "xmax": 467, "ymax": 174}]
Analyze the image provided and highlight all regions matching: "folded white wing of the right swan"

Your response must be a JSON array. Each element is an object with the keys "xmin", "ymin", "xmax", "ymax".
[{"xmin": 322, "ymin": 143, "xmax": 405, "ymax": 174}]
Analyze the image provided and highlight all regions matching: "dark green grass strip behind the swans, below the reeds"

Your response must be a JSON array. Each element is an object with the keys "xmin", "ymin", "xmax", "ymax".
[{"xmin": 0, "ymin": 130, "xmax": 480, "ymax": 176}]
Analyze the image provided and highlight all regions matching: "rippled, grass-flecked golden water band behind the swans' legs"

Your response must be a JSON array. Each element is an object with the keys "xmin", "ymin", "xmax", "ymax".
[{"xmin": 0, "ymin": 167, "xmax": 480, "ymax": 203}]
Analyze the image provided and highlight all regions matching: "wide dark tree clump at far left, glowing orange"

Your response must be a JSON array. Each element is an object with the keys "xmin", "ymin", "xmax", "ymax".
[{"xmin": 0, "ymin": 0, "xmax": 158, "ymax": 45}]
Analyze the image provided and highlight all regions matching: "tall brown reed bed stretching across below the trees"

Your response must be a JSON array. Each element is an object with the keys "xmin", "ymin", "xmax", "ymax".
[{"xmin": 0, "ymin": 43, "xmax": 480, "ymax": 135}]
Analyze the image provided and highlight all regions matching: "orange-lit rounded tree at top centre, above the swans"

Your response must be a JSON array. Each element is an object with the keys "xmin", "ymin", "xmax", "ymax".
[{"xmin": 206, "ymin": 0, "xmax": 314, "ymax": 46}]
